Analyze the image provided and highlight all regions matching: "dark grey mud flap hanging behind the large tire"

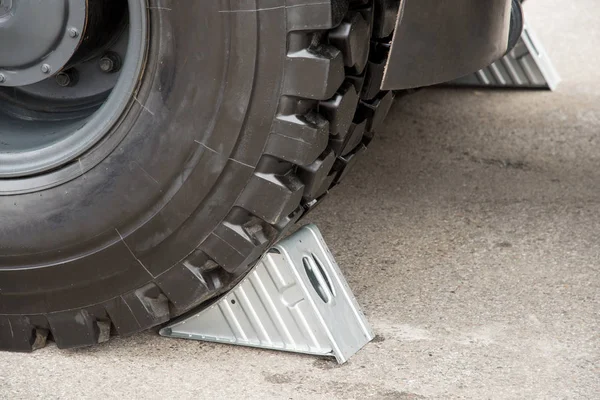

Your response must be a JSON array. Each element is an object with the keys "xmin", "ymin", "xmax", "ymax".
[{"xmin": 382, "ymin": 0, "xmax": 511, "ymax": 90}]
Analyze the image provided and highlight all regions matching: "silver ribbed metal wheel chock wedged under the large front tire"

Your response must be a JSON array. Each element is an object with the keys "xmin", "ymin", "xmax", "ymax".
[{"xmin": 160, "ymin": 225, "xmax": 374, "ymax": 363}]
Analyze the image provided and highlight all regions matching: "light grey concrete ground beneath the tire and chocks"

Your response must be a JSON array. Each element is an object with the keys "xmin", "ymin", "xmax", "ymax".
[{"xmin": 0, "ymin": 0, "xmax": 600, "ymax": 399}]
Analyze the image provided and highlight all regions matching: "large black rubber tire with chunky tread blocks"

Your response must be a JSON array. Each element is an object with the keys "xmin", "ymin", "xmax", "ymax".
[{"xmin": 0, "ymin": 0, "xmax": 395, "ymax": 351}]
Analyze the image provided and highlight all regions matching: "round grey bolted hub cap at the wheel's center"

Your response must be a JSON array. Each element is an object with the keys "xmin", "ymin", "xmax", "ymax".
[{"xmin": 0, "ymin": 0, "xmax": 87, "ymax": 87}]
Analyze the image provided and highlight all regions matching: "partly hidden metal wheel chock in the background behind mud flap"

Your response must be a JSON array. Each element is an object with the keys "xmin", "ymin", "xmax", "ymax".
[{"xmin": 450, "ymin": 24, "xmax": 560, "ymax": 90}]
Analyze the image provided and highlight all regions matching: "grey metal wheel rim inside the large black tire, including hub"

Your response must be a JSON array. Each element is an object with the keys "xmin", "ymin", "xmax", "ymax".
[{"xmin": 0, "ymin": 0, "xmax": 147, "ymax": 179}]
